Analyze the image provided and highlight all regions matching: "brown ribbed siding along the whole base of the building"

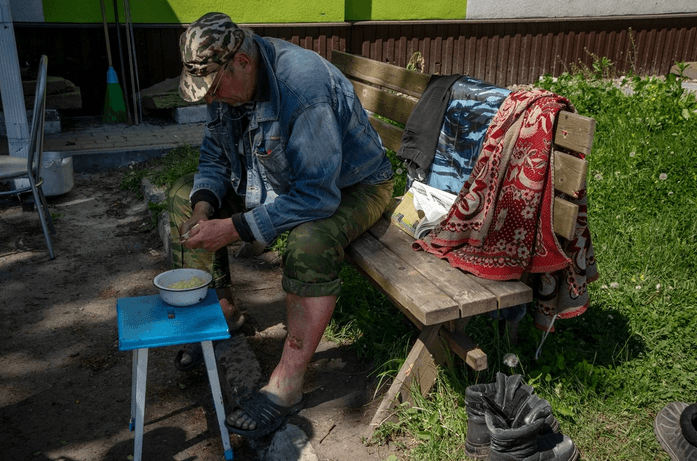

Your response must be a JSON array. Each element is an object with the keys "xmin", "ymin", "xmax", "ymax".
[{"xmin": 15, "ymin": 13, "xmax": 697, "ymax": 115}]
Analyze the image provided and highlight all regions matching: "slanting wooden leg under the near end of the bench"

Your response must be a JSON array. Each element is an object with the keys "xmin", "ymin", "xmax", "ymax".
[{"xmin": 370, "ymin": 325, "xmax": 442, "ymax": 427}]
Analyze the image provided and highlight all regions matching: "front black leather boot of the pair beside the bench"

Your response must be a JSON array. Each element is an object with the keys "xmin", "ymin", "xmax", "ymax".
[{"xmin": 484, "ymin": 395, "xmax": 580, "ymax": 461}]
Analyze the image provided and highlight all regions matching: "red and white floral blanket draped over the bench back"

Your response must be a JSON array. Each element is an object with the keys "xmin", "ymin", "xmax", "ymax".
[{"xmin": 414, "ymin": 90, "xmax": 598, "ymax": 330}]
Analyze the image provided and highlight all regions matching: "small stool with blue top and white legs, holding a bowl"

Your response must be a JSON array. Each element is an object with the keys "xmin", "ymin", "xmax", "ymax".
[{"xmin": 116, "ymin": 290, "xmax": 234, "ymax": 461}]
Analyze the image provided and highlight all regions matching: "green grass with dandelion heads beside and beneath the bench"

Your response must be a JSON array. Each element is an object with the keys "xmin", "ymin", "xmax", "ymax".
[{"xmin": 328, "ymin": 64, "xmax": 697, "ymax": 460}]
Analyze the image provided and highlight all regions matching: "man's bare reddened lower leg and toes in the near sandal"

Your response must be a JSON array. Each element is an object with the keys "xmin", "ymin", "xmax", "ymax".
[{"xmin": 227, "ymin": 293, "xmax": 336, "ymax": 430}]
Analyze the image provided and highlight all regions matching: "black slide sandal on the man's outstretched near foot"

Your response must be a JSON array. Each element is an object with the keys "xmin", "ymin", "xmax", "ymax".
[{"xmin": 225, "ymin": 391, "xmax": 305, "ymax": 438}]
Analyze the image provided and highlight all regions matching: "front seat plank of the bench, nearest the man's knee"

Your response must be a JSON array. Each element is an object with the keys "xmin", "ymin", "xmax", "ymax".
[{"xmin": 346, "ymin": 232, "xmax": 460, "ymax": 325}]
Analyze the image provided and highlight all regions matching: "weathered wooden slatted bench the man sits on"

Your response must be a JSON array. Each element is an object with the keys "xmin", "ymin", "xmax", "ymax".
[{"xmin": 331, "ymin": 51, "xmax": 595, "ymax": 426}]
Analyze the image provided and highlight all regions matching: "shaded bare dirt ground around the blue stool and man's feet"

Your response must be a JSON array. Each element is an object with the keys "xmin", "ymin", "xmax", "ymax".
[{"xmin": 0, "ymin": 171, "xmax": 400, "ymax": 461}]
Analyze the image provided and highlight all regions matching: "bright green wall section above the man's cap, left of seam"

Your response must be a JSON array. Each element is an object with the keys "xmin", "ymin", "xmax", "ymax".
[{"xmin": 43, "ymin": 0, "xmax": 344, "ymax": 24}]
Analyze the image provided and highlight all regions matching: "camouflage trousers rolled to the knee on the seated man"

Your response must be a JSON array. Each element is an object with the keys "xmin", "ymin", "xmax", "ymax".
[{"xmin": 168, "ymin": 174, "xmax": 394, "ymax": 297}]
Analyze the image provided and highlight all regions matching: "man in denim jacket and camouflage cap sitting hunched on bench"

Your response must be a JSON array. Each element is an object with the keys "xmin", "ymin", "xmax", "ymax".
[{"xmin": 170, "ymin": 9, "xmax": 393, "ymax": 437}]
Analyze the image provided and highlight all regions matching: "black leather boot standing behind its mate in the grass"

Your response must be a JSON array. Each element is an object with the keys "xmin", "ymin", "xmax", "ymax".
[{"xmin": 465, "ymin": 373, "xmax": 559, "ymax": 459}]
